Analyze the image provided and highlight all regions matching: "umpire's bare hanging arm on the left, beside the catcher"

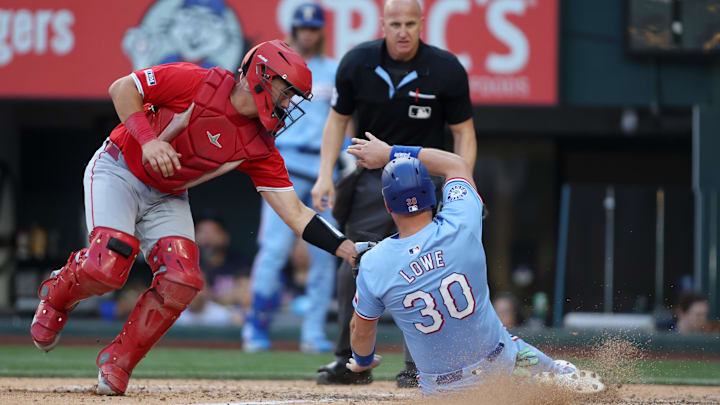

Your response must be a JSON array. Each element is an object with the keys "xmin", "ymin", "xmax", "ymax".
[{"xmin": 311, "ymin": 108, "xmax": 351, "ymax": 212}]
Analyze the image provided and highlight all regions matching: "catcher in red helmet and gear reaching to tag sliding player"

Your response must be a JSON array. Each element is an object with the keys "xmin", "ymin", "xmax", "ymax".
[{"xmin": 30, "ymin": 40, "xmax": 355, "ymax": 395}]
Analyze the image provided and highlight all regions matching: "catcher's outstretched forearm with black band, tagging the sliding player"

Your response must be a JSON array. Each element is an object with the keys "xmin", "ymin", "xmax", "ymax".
[{"xmin": 260, "ymin": 191, "xmax": 357, "ymax": 265}]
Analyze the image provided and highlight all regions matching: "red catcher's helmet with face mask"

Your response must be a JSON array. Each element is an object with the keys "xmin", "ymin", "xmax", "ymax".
[{"xmin": 240, "ymin": 39, "xmax": 312, "ymax": 137}]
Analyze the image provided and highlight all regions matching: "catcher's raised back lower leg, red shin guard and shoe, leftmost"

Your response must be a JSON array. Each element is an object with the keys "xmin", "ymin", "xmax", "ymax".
[{"xmin": 30, "ymin": 227, "xmax": 139, "ymax": 351}]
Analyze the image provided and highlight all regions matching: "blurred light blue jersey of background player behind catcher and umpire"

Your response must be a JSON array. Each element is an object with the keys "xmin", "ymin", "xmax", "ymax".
[{"xmin": 275, "ymin": 56, "xmax": 337, "ymax": 178}]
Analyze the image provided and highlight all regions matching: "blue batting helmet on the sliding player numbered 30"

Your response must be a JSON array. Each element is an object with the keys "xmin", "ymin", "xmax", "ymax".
[{"xmin": 382, "ymin": 157, "xmax": 437, "ymax": 214}]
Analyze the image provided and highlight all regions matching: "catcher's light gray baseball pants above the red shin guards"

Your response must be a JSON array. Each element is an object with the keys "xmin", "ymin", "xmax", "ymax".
[{"xmin": 83, "ymin": 139, "xmax": 195, "ymax": 257}]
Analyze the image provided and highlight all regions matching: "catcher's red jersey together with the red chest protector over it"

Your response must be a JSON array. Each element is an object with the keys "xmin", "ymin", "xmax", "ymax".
[{"xmin": 110, "ymin": 63, "xmax": 292, "ymax": 193}]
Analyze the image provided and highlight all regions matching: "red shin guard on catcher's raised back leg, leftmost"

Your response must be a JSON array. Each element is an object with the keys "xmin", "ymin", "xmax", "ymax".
[{"xmin": 38, "ymin": 227, "xmax": 140, "ymax": 311}]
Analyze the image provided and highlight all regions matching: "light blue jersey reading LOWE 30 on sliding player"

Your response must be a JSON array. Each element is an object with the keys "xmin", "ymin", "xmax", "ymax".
[{"xmin": 354, "ymin": 178, "xmax": 517, "ymax": 374}]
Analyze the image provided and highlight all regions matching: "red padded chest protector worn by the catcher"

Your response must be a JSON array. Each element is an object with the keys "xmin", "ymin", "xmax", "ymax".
[{"xmin": 118, "ymin": 67, "xmax": 275, "ymax": 193}]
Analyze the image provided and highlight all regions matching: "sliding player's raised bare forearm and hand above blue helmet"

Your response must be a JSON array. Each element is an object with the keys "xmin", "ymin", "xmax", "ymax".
[{"xmin": 348, "ymin": 132, "xmax": 475, "ymax": 187}]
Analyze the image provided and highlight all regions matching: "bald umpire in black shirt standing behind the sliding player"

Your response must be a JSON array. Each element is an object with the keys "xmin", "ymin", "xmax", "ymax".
[{"xmin": 312, "ymin": 0, "xmax": 477, "ymax": 387}]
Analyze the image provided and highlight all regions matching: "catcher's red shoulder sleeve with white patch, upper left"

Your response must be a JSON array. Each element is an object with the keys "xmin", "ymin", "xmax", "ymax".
[{"xmin": 132, "ymin": 62, "xmax": 207, "ymax": 109}]
